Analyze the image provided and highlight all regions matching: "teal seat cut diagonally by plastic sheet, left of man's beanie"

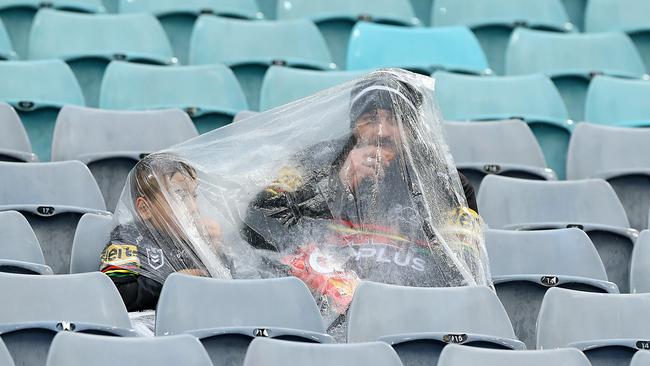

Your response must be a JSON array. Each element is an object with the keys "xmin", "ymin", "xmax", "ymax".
[{"xmin": 260, "ymin": 66, "xmax": 365, "ymax": 111}]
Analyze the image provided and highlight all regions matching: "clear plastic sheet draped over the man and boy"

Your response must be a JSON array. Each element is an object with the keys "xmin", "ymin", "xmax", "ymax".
[{"xmin": 115, "ymin": 69, "xmax": 491, "ymax": 334}]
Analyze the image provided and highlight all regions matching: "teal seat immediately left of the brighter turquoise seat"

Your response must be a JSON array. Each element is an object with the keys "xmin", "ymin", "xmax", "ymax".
[{"xmin": 190, "ymin": 15, "xmax": 336, "ymax": 110}]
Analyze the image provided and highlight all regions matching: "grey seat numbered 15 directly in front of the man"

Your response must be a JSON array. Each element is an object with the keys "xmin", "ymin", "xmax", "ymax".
[{"xmin": 348, "ymin": 282, "xmax": 526, "ymax": 366}]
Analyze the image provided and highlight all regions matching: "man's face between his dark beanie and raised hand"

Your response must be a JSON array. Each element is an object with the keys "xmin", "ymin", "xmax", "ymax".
[{"xmin": 355, "ymin": 109, "xmax": 400, "ymax": 147}]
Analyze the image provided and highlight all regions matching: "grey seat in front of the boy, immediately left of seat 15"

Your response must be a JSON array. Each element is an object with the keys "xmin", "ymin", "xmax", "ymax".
[{"xmin": 156, "ymin": 274, "xmax": 331, "ymax": 366}]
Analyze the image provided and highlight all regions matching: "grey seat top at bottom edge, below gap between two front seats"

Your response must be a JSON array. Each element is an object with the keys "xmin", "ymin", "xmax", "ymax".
[{"xmin": 244, "ymin": 338, "xmax": 402, "ymax": 366}]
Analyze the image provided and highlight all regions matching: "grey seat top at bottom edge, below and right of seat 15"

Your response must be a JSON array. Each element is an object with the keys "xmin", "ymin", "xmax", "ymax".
[{"xmin": 438, "ymin": 345, "xmax": 591, "ymax": 366}]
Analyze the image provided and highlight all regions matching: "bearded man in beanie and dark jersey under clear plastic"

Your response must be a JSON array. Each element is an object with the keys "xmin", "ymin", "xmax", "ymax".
[{"xmin": 243, "ymin": 72, "xmax": 489, "ymax": 319}]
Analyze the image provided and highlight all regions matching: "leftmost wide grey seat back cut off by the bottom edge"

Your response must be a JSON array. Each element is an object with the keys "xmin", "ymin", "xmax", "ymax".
[{"xmin": 46, "ymin": 332, "xmax": 212, "ymax": 366}]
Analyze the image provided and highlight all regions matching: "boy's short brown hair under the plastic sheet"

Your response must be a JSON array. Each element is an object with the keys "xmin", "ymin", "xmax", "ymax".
[{"xmin": 130, "ymin": 154, "xmax": 196, "ymax": 202}]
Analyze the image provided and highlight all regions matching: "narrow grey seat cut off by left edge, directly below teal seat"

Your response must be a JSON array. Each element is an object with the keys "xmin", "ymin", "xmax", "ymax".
[{"xmin": 0, "ymin": 102, "xmax": 38, "ymax": 162}]
